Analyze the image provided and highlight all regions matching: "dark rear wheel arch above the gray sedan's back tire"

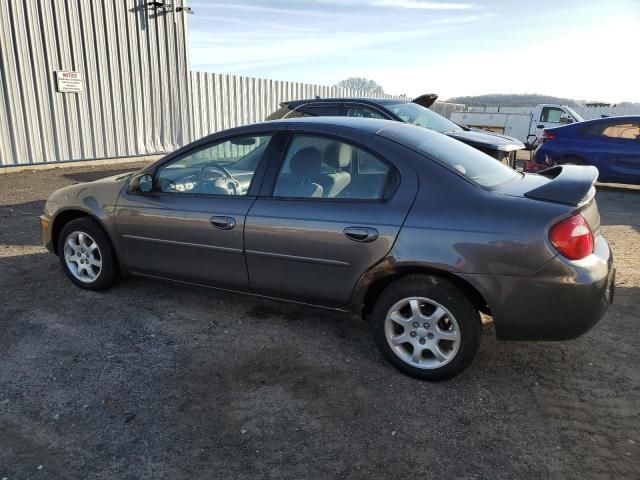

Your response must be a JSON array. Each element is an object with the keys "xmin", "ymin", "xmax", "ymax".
[{"xmin": 356, "ymin": 262, "xmax": 491, "ymax": 318}]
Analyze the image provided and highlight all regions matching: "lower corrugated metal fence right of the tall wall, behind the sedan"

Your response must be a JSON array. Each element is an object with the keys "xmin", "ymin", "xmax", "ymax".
[{"xmin": 190, "ymin": 72, "xmax": 404, "ymax": 140}]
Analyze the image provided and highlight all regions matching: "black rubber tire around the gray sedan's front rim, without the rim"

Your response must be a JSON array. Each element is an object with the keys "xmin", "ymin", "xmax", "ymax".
[{"xmin": 58, "ymin": 217, "xmax": 118, "ymax": 290}]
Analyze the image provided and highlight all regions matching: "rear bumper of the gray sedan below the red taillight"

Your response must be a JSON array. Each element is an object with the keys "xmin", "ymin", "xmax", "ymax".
[{"xmin": 464, "ymin": 236, "xmax": 615, "ymax": 340}]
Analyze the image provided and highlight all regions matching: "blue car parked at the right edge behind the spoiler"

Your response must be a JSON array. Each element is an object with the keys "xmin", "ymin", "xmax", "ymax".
[{"xmin": 524, "ymin": 115, "xmax": 640, "ymax": 184}]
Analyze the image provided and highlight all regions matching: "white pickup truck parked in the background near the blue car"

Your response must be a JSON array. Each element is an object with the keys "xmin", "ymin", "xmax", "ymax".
[{"xmin": 449, "ymin": 104, "xmax": 584, "ymax": 149}]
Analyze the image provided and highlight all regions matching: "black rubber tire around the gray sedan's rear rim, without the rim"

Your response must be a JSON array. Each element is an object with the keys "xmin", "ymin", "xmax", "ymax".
[{"xmin": 370, "ymin": 275, "xmax": 481, "ymax": 381}]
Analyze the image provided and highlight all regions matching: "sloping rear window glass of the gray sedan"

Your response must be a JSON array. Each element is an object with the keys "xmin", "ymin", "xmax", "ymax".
[{"xmin": 378, "ymin": 125, "xmax": 522, "ymax": 188}]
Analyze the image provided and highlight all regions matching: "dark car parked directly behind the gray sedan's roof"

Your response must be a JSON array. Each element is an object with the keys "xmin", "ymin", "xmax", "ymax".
[{"xmin": 266, "ymin": 94, "xmax": 525, "ymax": 167}]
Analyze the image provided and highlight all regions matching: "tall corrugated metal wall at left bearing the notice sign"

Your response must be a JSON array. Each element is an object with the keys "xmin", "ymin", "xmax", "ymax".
[{"xmin": 0, "ymin": 0, "xmax": 190, "ymax": 166}]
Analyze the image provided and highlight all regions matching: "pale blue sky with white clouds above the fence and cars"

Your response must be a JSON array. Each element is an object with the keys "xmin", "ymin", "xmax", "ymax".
[{"xmin": 188, "ymin": 0, "xmax": 640, "ymax": 102}]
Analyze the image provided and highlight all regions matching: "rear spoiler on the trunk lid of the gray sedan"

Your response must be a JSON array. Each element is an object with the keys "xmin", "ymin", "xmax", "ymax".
[{"xmin": 524, "ymin": 165, "xmax": 599, "ymax": 206}]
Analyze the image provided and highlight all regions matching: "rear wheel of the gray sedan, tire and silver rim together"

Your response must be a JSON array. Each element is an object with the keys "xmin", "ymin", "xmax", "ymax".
[{"xmin": 371, "ymin": 275, "xmax": 481, "ymax": 380}]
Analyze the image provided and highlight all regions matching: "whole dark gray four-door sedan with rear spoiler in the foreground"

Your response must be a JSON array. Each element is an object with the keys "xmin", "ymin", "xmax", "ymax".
[{"xmin": 41, "ymin": 117, "xmax": 614, "ymax": 380}]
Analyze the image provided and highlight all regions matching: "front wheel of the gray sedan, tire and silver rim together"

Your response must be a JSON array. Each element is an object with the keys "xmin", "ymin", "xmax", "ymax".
[{"xmin": 58, "ymin": 218, "xmax": 117, "ymax": 290}]
